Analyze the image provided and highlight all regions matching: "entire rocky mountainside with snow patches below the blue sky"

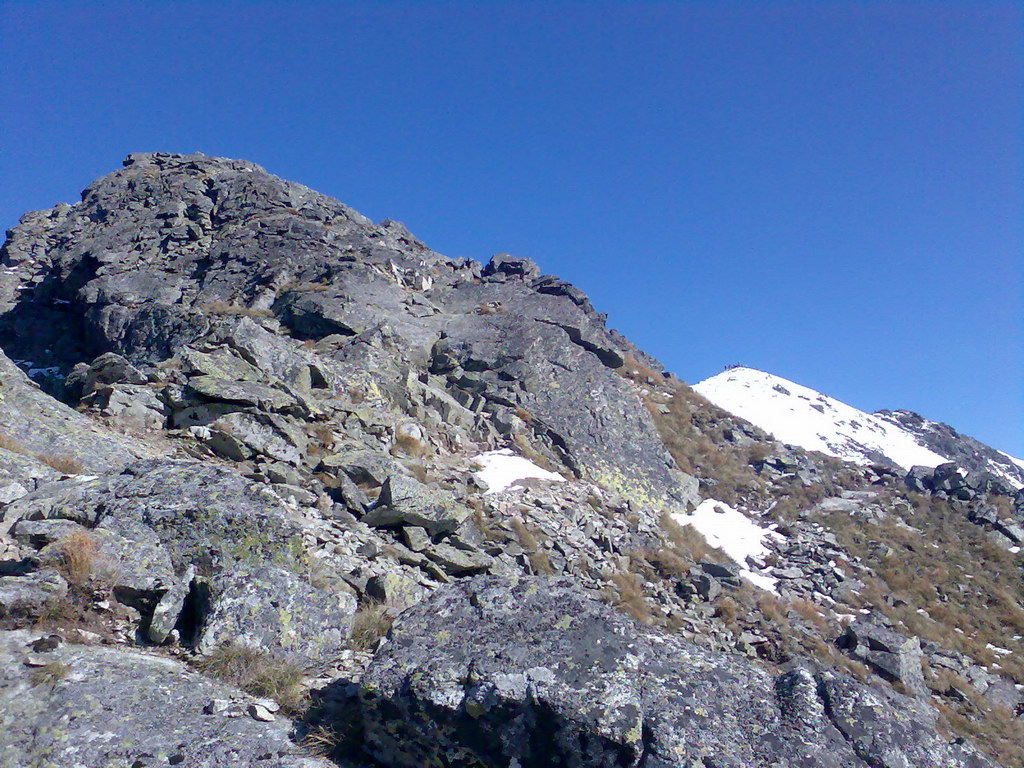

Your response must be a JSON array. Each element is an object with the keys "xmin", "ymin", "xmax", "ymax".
[{"xmin": 0, "ymin": 154, "xmax": 1024, "ymax": 768}]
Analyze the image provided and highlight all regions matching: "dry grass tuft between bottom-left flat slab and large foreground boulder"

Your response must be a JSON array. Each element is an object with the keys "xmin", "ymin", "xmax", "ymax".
[{"xmin": 195, "ymin": 643, "xmax": 305, "ymax": 715}]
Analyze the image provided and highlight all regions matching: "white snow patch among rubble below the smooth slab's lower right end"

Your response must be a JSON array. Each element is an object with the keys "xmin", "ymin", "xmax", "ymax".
[{"xmin": 672, "ymin": 499, "xmax": 782, "ymax": 592}]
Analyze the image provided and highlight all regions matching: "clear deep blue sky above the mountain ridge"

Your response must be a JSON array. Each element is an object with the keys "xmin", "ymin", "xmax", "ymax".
[{"xmin": 0, "ymin": 0, "xmax": 1024, "ymax": 457}]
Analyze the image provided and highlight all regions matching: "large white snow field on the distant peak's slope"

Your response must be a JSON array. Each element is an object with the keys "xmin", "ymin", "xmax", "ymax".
[{"xmin": 693, "ymin": 368, "xmax": 948, "ymax": 469}]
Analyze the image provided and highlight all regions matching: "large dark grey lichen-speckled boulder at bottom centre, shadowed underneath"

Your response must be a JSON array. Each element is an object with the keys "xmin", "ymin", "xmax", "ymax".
[{"xmin": 361, "ymin": 577, "xmax": 989, "ymax": 768}]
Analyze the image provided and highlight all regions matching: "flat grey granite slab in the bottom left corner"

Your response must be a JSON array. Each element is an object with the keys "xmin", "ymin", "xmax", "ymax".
[{"xmin": 0, "ymin": 632, "xmax": 333, "ymax": 768}]
